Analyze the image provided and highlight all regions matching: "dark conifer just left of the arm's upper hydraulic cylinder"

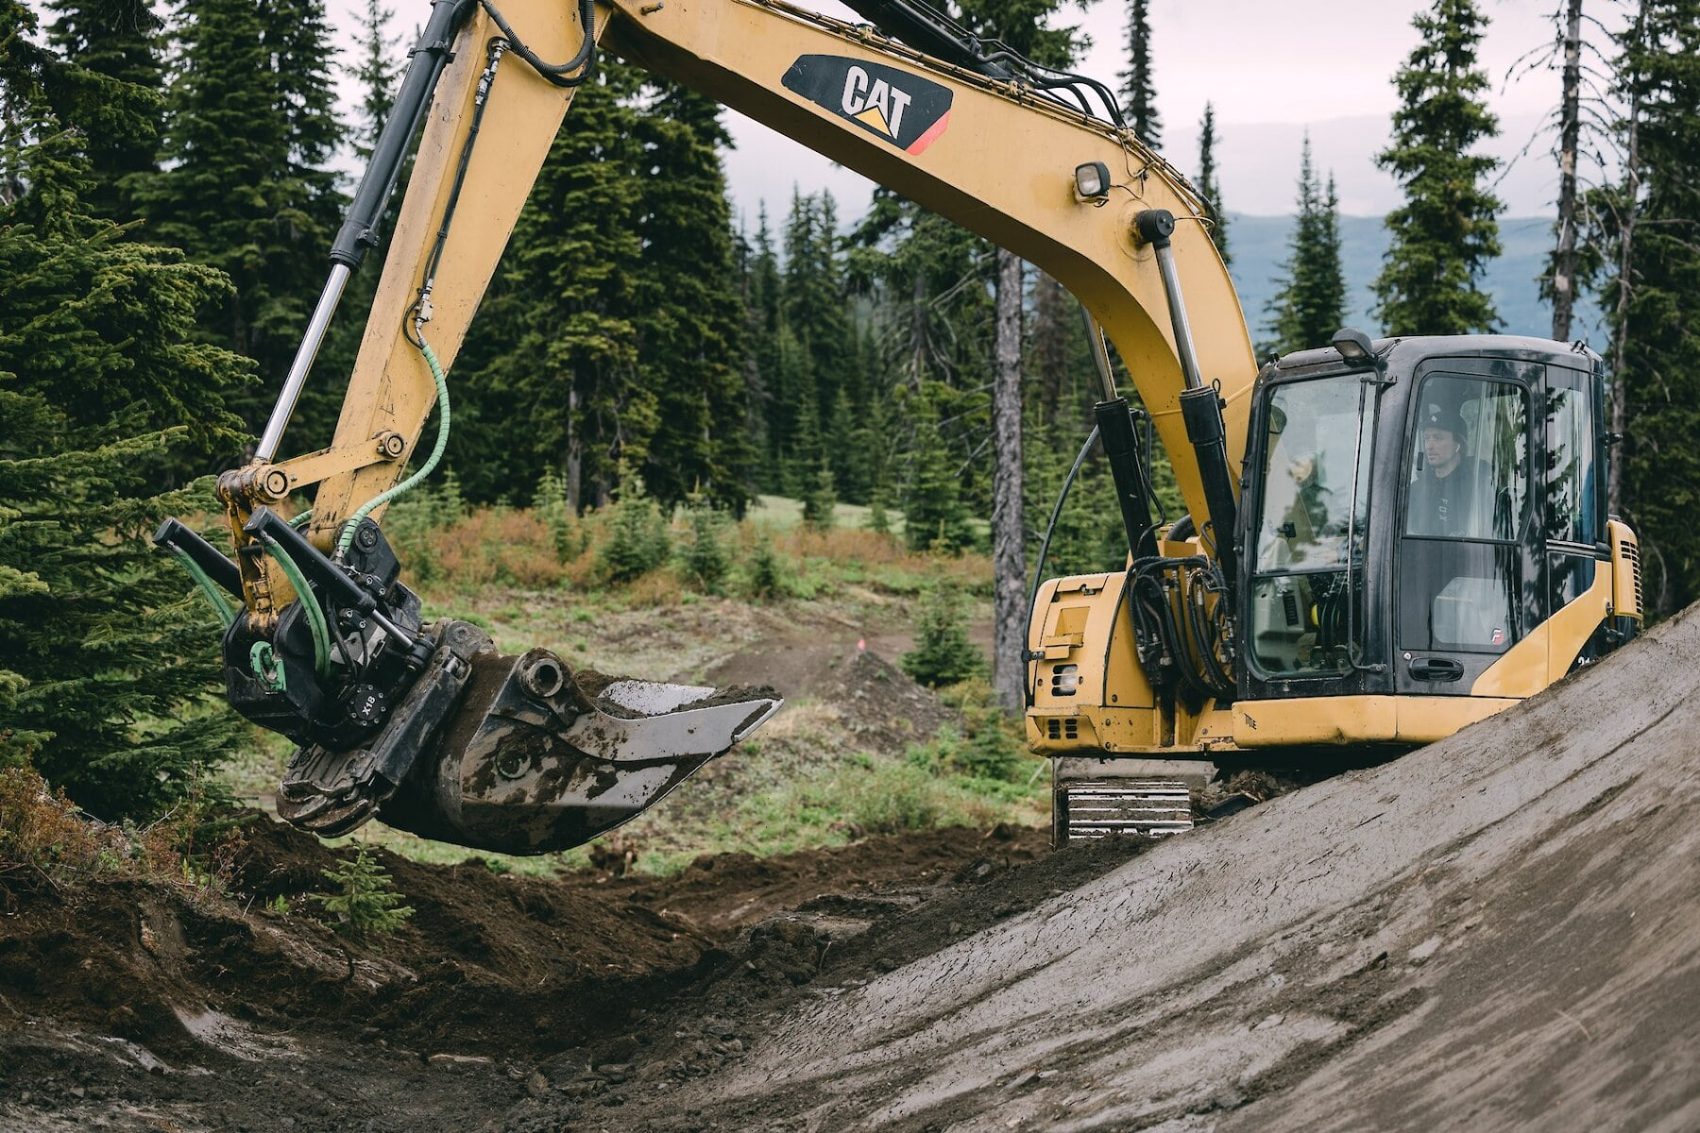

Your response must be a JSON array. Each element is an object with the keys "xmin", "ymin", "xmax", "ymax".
[{"xmin": 136, "ymin": 0, "xmax": 342, "ymax": 429}]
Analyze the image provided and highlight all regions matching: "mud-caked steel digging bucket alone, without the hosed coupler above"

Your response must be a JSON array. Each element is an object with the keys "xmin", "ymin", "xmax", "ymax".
[{"xmin": 277, "ymin": 621, "xmax": 782, "ymax": 854}]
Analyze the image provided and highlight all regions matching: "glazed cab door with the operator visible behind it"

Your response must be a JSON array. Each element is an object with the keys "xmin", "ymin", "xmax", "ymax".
[{"xmin": 1394, "ymin": 359, "xmax": 1549, "ymax": 696}]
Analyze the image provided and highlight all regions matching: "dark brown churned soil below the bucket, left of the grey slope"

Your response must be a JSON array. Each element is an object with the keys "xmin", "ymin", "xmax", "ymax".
[{"xmin": 0, "ymin": 820, "xmax": 1081, "ymax": 1133}]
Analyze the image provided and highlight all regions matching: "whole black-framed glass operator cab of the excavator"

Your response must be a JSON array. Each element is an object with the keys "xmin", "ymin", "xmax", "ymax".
[{"xmin": 1238, "ymin": 335, "xmax": 1618, "ymax": 701}]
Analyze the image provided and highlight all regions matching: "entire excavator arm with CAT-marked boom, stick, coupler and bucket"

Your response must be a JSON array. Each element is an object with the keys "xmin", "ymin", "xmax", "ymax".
[{"xmin": 158, "ymin": 0, "xmax": 1255, "ymax": 852}]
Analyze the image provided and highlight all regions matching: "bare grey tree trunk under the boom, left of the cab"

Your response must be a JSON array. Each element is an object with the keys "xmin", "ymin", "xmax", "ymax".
[{"xmin": 991, "ymin": 248, "xmax": 1027, "ymax": 715}]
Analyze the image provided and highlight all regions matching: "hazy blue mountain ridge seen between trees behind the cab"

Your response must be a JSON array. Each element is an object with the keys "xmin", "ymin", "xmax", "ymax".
[{"xmin": 1227, "ymin": 213, "xmax": 1605, "ymax": 350}]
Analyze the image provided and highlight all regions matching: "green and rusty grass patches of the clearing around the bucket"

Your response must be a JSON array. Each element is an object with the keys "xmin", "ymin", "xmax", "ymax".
[{"xmin": 209, "ymin": 493, "xmax": 1006, "ymax": 874}]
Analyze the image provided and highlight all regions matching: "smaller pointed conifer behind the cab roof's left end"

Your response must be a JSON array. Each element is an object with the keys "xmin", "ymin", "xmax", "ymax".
[{"xmin": 1268, "ymin": 134, "xmax": 1346, "ymax": 354}]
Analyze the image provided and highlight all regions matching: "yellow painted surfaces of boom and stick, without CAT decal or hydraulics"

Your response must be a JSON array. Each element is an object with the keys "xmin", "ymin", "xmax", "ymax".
[{"xmin": 272, "ymin": 0, "xmax": 1256, "ymax": 568}]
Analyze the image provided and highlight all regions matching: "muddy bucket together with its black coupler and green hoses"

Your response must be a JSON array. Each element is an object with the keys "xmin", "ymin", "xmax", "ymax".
[{"xmin": 156, "ymin": 509, "xmax": 782, "ymax": 854}]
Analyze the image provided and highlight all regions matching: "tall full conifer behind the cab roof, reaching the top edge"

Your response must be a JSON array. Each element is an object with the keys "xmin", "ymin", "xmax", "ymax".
[{"xmin": 1375, "ymin": 0, "xmax": 1503, "ymax": 335}]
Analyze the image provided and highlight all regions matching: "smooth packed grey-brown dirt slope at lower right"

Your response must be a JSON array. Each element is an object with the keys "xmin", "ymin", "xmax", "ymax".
[{"xmin": 651, "ymin": 612, "xmax": 1700, "ymax": 1133}]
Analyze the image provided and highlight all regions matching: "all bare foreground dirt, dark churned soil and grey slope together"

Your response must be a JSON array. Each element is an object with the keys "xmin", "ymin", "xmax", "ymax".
[{"xmin": 0, "ymin": 595, "xmax": 1700, "ymax": 1133}]
